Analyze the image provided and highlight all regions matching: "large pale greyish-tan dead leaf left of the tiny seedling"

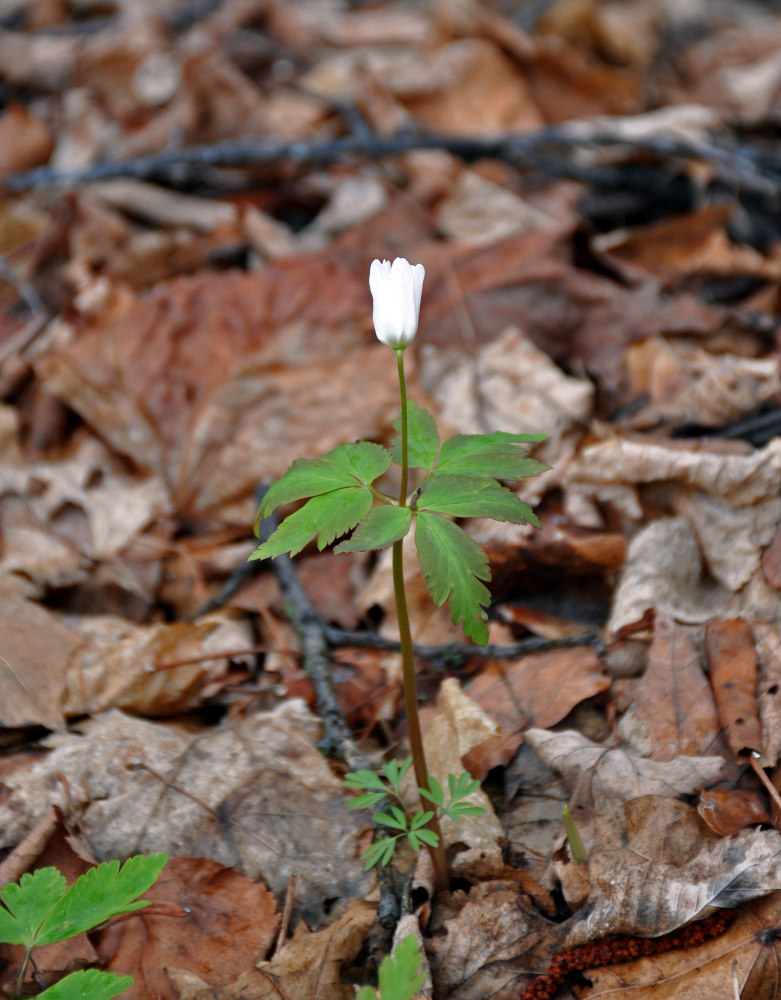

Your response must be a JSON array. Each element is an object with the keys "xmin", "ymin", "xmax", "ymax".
[{"xmin": 0, "ymin": 700, "xmax": 370, "ymax": 922}]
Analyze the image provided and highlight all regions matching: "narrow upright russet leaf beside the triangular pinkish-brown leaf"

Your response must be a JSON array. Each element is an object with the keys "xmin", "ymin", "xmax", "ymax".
[{"xmin": 705, "ymin": 618, "xmax": 762, "ymax": 754}]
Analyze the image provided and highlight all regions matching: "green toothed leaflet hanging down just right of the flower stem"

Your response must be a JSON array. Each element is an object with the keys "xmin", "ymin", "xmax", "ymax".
[{"xmin": 415, "ymin": 511, "xmax": 491, "ymax": 646}]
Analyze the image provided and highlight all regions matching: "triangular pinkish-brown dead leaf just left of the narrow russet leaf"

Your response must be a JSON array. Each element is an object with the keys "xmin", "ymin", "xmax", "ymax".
[{"xmin": 622, "ymin": 614, "xmax": 726, "ymax": 761}]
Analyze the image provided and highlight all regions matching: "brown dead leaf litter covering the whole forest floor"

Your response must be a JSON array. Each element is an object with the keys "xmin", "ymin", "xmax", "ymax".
[{"xmin": 0, "ymin": 0, "xmax": 781, "ymax": 1000}]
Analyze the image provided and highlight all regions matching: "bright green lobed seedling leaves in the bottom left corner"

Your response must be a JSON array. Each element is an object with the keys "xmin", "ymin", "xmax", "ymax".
[{"xmin": 0, "ymin": 854, "xmax": 168, "ymax": 1000}]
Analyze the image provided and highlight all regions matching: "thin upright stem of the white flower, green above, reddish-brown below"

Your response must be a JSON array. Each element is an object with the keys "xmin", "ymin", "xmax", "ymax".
[{"xmin": 393, "ymin": 348, "xmax": 448, "ymax": 889}]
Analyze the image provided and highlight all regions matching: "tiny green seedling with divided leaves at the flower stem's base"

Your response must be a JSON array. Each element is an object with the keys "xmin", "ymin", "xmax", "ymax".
[{"xmin": 344, "ymin": 757, "xmax": 485, "ymax": 869}]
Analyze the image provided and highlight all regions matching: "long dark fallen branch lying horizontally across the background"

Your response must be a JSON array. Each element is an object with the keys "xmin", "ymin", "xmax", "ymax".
[{"xmin": 4, "ymin": 116, "xmax": 781, "ymax": 198}]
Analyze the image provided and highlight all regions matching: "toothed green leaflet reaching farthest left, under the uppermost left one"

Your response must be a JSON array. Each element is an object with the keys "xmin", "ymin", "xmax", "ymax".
[{"xmin": 250, "ymin": 486, "xmax": 372, "ymax": 559}]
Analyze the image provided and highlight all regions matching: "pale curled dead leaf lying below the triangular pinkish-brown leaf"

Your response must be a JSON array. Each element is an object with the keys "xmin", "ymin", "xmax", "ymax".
[{"xmin": 526, "ymin": 729, "xmax": 725, "ymax": 802}]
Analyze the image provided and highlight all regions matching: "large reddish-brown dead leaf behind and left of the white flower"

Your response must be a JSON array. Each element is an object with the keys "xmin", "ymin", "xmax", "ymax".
[{"xmin": 32, "ymin": 258, "xmax": 396, "ymax": 517}]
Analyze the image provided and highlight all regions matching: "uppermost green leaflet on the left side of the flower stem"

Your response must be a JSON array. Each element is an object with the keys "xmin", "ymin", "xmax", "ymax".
[{"xmin": 256, "ymin": 441, "xmax": 391, "ymax": 520}]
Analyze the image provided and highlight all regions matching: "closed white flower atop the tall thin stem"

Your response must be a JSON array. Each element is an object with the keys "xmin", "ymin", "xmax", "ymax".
[{"xmin": 369, "ymin": 257, "xmax": 426, "ymax": 348}]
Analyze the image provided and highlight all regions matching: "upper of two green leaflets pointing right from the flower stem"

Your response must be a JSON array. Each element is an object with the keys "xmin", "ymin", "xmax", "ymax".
[{"xmin": 437, "ymin": 431, "xmax": 548, "ymax": 479}]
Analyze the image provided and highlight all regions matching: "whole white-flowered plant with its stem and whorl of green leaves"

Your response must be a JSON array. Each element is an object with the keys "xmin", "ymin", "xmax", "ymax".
[{"xmin": 250, "ymin": 257, "xmax": 548, "ymax": 889}]
